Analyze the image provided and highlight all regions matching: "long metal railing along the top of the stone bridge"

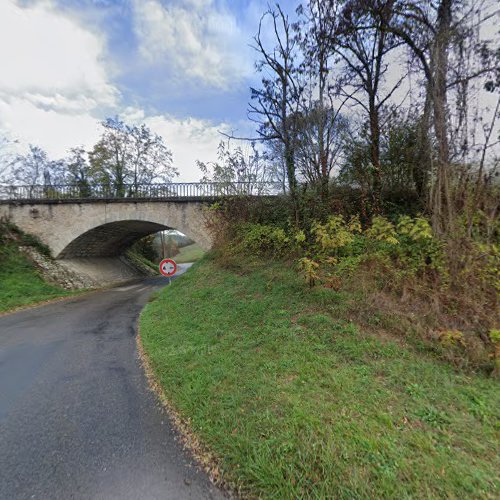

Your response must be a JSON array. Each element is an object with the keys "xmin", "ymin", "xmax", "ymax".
[{"xmin": 0, "ymin": 182, "xmax": 283, "ymax": 201}]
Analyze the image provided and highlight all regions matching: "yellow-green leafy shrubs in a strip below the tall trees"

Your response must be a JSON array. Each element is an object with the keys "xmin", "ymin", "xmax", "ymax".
[{"xmin": 229, "ymin": 215, "xmax": 492, "ymax": 291}]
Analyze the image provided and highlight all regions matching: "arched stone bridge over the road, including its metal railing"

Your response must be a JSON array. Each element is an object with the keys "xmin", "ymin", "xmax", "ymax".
[{"xmin": 0, "ymin": 183, "xmax": 277, "ymax": 281}]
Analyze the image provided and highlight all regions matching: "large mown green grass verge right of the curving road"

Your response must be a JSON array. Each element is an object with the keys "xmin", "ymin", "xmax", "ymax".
[{"xmin": 141, "ymin": 259, "xmax": 500, "ymax": 498}]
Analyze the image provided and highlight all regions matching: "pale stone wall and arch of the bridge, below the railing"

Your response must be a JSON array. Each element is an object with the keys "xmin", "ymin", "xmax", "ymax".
[{"xmin": 0, "ymin": 201, "xmax": 212, "ymax": 258}]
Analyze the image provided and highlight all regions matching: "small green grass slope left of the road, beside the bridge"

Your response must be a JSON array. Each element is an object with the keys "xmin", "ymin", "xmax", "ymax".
[{"xmin": 0, "ymin": 240, "xmax": 74, "ymax": 312}]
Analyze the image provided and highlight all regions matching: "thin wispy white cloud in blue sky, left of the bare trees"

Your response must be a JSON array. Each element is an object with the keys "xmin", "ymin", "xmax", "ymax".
[{"xmin": 133, "ymin": 0, "xmax": 252, "ymax": 89}]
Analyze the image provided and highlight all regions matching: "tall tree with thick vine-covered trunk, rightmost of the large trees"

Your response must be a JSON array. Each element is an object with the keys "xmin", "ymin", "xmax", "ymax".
[{"xmin": 378, "ymin": 0, "xmax": 498, "ymax": 233}]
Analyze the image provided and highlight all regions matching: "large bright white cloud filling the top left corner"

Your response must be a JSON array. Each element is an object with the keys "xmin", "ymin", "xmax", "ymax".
[{"xmin": 0, "ymin": 0, "xmax": 119, "ymax": 156}]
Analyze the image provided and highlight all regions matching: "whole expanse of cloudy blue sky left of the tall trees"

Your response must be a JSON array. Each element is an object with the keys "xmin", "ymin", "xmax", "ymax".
[{"xmin": 0, "ymin": 0, "xmax": 296, "ymax": 181}]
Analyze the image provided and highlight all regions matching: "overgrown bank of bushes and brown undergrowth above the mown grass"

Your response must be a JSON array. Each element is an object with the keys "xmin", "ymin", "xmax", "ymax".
[{"xmin": 205, "ymin": 200, "xmax": 500, "ymax": 372}]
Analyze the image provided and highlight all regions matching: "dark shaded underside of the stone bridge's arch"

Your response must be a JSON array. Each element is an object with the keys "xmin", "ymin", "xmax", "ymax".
[{"xmin": 57, "ymin": 220, "xmax": 170, "ymax": 259}]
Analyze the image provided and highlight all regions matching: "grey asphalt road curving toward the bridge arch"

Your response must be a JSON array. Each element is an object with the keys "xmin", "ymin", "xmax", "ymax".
[{"xmin": 0, "ymin": 268, "xmax": 223, "ymax": 500}]
